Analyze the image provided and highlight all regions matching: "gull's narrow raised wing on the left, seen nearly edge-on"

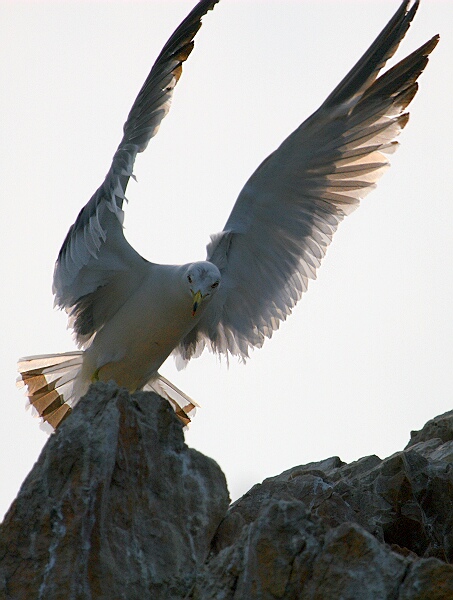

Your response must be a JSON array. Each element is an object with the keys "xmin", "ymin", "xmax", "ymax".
[{"xmin": 53, "ymin": 0, "xmax": 219, "ymax": 345}]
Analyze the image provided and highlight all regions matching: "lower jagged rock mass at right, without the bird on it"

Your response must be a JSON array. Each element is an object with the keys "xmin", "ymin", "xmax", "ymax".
[{"xmin": 192, "ymin": 411, "xmax": 453, "ymax": 600}]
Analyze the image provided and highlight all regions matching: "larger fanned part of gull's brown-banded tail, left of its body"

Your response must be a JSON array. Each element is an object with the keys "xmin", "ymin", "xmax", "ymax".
[{"xmin": 17, "ymin": 351, "xmax": 83, "ymax": 429}]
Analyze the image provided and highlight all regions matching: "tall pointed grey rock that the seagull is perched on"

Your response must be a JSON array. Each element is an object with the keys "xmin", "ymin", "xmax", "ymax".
[{"xmin": 0, "ymin": 384, "xmax": 229, "ymax": 600}]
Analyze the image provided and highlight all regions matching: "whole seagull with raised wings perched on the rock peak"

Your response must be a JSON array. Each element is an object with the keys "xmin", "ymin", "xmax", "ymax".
[{"xmin": 18, "ymin": 0, "xmax": 439, "ymax": 429}]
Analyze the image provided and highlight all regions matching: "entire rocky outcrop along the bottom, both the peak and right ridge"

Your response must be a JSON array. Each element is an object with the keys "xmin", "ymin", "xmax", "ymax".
[{"xmin": 0, "ymin": 384, "xmax": 453, "ymax": 600}]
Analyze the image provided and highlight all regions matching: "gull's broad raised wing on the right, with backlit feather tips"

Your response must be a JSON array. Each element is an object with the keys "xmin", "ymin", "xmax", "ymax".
[{"xmin": 176, "ymin": 0, "xmax": 438, "ymax": 361}]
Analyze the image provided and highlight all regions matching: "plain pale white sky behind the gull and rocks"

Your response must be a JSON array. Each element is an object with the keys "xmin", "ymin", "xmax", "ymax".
[{"xmin": 0, "ymin": 0, "xmax": 453, "ymax": 516}]
